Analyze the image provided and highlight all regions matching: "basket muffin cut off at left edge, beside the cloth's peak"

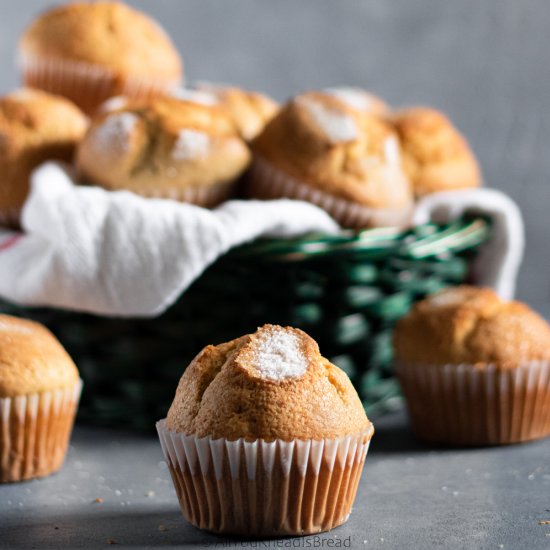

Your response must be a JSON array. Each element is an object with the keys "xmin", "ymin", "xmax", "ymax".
[{"xmin": 0, "ymin": 89, "xmax": 87, "ymax": 226}]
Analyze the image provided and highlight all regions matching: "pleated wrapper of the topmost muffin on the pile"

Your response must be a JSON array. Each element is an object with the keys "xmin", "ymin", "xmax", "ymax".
[{"xmin": 19, "ymin": 54, "xmax": 181, "ymax": 113}]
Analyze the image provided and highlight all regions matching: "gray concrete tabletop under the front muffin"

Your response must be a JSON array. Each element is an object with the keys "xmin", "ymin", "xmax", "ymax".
[{"xmin": 0, "ymin": 414, "xmax": 550, "ymax": 550}]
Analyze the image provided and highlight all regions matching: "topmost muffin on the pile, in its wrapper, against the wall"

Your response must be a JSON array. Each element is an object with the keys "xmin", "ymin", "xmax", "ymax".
[{"xmin": 19, "ymin": 2, "xmax": 183, "ymax": 113}]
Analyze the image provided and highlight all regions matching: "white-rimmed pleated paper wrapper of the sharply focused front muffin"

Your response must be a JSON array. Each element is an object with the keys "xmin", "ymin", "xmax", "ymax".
[{"xmin": 157, "ymin": 420, "xmax": 374, "ymax": 536}]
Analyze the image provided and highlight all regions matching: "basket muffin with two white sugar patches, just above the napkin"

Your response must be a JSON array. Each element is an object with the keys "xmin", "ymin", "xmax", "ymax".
[{"xmin": 77, "ymin": 97, "xmax": 250, "ymax": 206}]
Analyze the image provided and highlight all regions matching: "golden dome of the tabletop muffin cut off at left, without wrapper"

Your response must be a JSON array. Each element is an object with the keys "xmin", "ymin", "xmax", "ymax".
[{"xmin": 0, "ymin": 315, "xmax": 78, "ymax": 397}]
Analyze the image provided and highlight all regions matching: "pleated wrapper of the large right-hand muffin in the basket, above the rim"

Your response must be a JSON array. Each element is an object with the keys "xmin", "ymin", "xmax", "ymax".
[{"xmin": 249, "ymin": 157, "xmax": 412, "ymax": 229}]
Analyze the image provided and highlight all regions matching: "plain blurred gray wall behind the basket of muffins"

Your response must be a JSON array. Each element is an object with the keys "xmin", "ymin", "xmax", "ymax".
[{"xmin": 0, "ymin": 0, "xmax": 550, "ymax": 317}]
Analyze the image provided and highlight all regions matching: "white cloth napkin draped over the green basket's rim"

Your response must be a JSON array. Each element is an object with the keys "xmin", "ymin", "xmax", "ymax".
[{"xmin": 0, "ymin": 163, "xmax": 523, "ymax": 317}]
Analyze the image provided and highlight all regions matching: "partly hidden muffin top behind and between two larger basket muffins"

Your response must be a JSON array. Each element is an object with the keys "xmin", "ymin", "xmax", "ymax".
[{"xmin": 196, "ymin": 82, "xmax": 279, "ymax": 141}]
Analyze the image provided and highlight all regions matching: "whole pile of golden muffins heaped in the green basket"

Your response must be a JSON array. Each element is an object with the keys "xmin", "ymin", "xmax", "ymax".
[{"xmin": 0, "ymin": 2, "xmax": 481, "ymax": 228}]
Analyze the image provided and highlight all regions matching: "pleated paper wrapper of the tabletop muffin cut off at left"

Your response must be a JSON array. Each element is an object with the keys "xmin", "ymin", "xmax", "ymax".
[{"xmin": 0, "ymin": 381, "xmax": 82, "ymax": 482}]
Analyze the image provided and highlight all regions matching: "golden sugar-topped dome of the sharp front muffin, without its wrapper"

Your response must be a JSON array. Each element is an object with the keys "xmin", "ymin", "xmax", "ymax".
[{"xmin": 166, "ymin": 325, "xmax": 371, "ymax": 441}]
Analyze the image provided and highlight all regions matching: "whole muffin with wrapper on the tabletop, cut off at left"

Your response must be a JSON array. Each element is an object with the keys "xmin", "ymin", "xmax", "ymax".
[{"xmin": 0, "ymin": 315, "xmax": 82, "ymax": 482}]
